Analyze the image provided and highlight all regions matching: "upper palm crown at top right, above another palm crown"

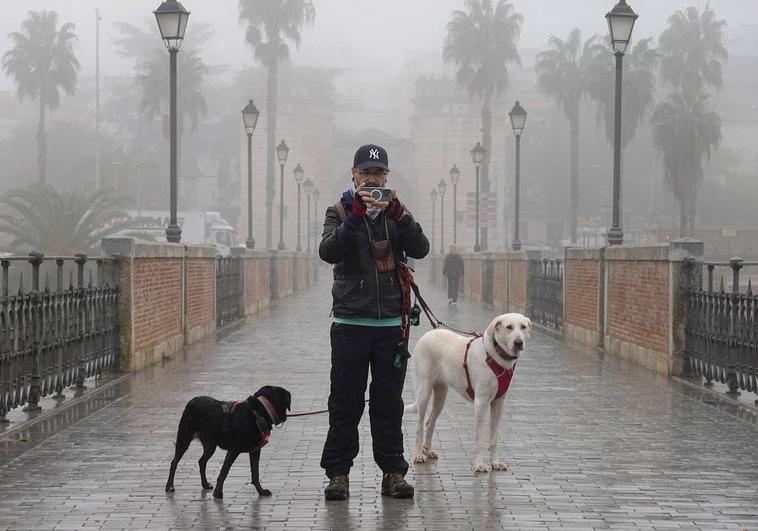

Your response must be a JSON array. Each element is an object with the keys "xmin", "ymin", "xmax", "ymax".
[{"xmin": 660, "ymin": 2, "xmax": 729, "ymax": 95}]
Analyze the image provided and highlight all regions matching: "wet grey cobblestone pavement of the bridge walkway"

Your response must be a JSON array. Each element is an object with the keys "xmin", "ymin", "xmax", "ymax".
[{"xmin": 0, "ymin": 273, "xmax": 758, "ymax": 530}]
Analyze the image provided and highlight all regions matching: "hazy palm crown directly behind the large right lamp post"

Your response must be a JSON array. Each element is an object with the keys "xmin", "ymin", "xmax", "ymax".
[{"xmin": 588, "ymin": 37, "xmax": 660, "ymax": 150}]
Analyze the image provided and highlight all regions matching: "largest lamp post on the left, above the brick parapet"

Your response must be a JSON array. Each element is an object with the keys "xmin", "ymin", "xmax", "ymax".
[{"xmin": 153, "ymin": 0, "xmax": 190, "ymax": 243}]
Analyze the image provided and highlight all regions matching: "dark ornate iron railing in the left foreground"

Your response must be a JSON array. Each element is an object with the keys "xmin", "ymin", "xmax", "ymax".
[{"xmin": 0, "ymin": 252, "xmax": 119, "ymax": 422}]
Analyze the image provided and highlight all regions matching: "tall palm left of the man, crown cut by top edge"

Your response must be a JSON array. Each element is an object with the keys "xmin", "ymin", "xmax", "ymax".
[{"xmin": 239, "ymin": 0, "xmax": 316, "ymax": 248}]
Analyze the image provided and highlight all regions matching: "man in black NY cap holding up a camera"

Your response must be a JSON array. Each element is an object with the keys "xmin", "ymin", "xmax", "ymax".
[{"xmin": 319, "ymin": 144, "xmax": 429, "ymax": 500}]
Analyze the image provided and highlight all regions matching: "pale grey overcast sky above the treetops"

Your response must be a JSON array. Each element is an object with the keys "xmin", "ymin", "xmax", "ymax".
[{"xmin": 0, "ymin": 0, "xmax": 758, "ymax": 90}]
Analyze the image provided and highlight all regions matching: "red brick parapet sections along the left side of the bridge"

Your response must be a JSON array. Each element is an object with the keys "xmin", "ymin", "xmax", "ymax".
[{"xmin": 102, "ymin": 238, "xmax": 315, "ymax": 371}]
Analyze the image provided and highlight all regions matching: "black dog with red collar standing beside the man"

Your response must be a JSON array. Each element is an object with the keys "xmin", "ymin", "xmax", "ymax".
[{"xmin": 166, "ymin": 386, "xmax": 291, "ymax": 498}]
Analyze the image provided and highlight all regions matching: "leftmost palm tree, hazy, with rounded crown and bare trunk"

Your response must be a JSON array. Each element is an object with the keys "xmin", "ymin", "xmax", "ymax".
[{"xmin": 2, "ymin": 11, "xmax": 79, "ymax": 183}]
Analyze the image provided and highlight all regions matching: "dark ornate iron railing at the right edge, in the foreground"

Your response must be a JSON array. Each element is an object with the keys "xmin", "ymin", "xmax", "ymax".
[{"xmin": 684, "ymin": 258, "xmax": 758, "ymax": 395}]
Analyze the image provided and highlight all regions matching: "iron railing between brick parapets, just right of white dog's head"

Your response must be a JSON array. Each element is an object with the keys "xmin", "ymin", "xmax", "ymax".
[{"xmin": 530, "ymin": 258, "xmax": 563, "ymax": 330}]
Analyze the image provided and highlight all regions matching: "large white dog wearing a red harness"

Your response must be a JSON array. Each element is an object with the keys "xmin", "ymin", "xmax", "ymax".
[{"xmin": 405, "ymin": 313, "xmax": 532, "ymax": 472}]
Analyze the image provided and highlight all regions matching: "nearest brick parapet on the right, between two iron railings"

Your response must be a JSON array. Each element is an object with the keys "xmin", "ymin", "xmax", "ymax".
[{"xmin": 564, "ymin": 239, "xmax": 703, "ymax": 375}]
